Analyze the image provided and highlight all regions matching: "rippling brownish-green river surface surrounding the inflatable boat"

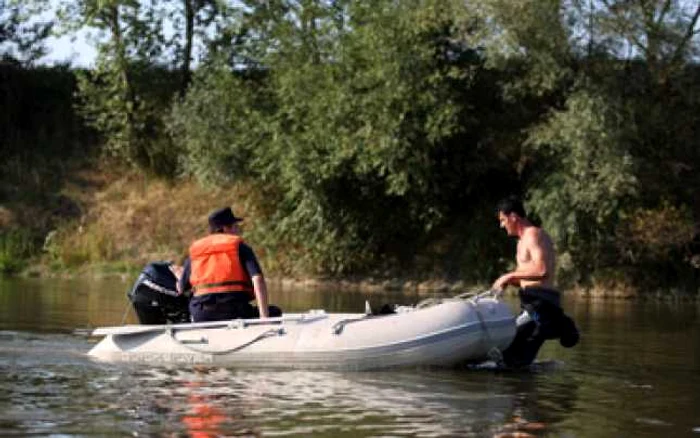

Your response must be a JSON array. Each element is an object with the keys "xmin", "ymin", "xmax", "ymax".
[{"xmin": 0, "ymin": 279, "xmax": 700, "ymax": 438}]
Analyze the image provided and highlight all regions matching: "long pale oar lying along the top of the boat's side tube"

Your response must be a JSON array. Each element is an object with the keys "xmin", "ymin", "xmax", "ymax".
[{"xmin": 92, "ymin": 311, "xmax": 328, "ymax": 336}]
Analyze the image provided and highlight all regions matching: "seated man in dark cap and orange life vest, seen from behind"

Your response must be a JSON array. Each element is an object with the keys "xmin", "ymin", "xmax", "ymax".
[{"xmin": 178, "ymin": 207, "xmax": 282, "ymax": 322}]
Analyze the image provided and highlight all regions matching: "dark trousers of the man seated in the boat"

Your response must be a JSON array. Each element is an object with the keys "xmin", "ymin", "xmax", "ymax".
[{"xmin": 190, "ymin": 292, "xmax": 282, "ymax": 322}]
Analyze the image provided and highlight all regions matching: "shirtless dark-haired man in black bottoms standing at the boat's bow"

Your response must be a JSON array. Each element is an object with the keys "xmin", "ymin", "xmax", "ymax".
[{"xmin": 492, "ymin": 197, "xmax": 578, "ymax": 367}]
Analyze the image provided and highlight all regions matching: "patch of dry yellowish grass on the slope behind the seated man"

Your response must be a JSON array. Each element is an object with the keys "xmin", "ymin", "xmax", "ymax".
[{"xmin": 46, "ymin": 175, "xmax": 262, "ymax": 268}]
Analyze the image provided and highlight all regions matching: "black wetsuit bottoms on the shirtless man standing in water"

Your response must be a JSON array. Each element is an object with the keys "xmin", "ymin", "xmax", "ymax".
[{"xmin": 503, "ymin": 288, "xmax": 579, "ymax": 368}]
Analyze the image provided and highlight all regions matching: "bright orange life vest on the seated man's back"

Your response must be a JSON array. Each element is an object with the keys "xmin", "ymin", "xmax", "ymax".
[{"xmin": 190, "ymin": 233, "xmax": 255, "ymax": 300}]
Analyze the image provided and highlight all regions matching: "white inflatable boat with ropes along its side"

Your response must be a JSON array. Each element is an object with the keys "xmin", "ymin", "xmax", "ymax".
[{"xmin": 88, "ymin": 293, "xmax": 515, "ymax": 370}]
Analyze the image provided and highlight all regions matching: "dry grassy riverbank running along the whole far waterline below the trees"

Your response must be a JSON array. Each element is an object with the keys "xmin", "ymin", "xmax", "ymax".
[{"xmin": 3, "ymin": 168, "xmax": 700, "ymax": 300}]
